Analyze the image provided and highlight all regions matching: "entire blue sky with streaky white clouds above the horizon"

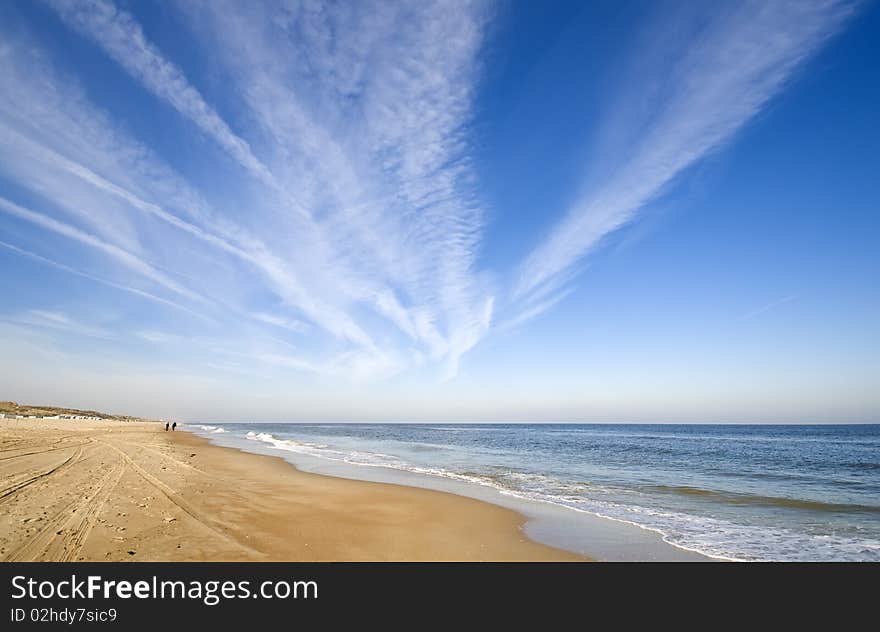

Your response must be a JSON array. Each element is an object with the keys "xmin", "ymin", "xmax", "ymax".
[{"xmin": 0, "ymin": 0, "xmax": 880, "ymax": 423}]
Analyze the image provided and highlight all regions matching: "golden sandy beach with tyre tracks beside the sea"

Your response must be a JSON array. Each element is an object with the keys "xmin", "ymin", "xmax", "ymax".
[{"xmin": 0, "ymin": 419, "xmax": 584, "ymax": 561}]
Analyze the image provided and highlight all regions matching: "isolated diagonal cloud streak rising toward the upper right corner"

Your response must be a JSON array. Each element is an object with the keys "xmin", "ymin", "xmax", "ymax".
[{"xmin": 512, "ymin": 0, "xmax": 855, "ymax": 310}]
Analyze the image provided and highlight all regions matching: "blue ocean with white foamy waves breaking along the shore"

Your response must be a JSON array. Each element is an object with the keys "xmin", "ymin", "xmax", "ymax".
[{"xmin": 187, "ymin": 423, "xmax": 880, "ymax": 561}]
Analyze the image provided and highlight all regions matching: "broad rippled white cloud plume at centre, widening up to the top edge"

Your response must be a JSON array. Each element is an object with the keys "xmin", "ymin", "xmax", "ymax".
[{"xmin": 182, "ymin": 2, "xmax": 490, "ymax": 370}]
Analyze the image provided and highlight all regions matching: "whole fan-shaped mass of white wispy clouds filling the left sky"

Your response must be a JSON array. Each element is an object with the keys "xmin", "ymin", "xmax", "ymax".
[{"xmin": 0, "ymin": 0, "xmax": 494, "ymax": 378}]
